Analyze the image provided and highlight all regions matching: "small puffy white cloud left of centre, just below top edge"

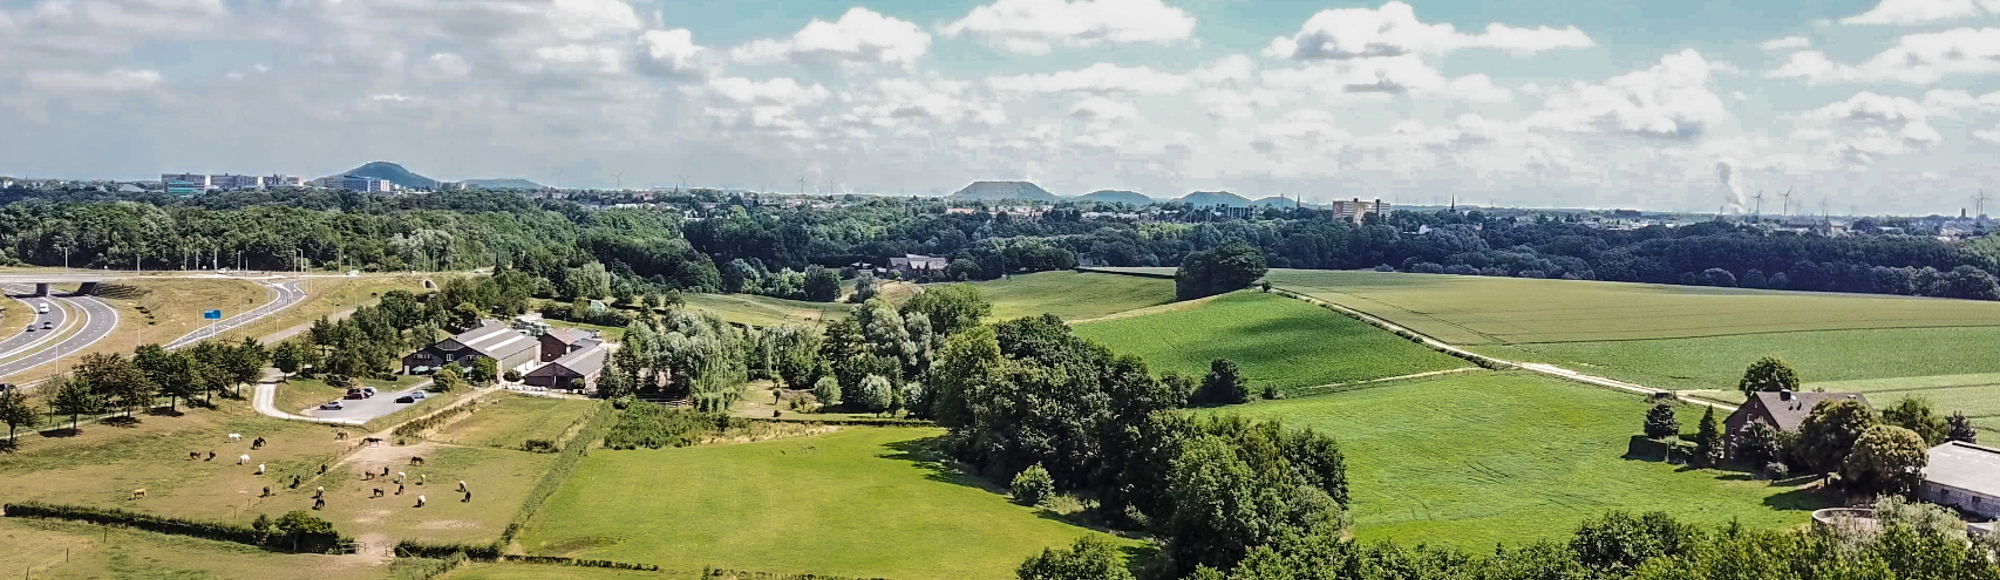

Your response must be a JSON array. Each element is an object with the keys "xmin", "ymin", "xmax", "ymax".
[{"xmin": 730, "ymin": 6, "xmax": 930, "ymax": 66}]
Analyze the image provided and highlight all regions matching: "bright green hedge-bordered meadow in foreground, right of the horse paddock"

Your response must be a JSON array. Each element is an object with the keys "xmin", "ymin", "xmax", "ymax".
[{"xmin": 520, "ymin": 428, "xmax": 1128, "ymax": 580}]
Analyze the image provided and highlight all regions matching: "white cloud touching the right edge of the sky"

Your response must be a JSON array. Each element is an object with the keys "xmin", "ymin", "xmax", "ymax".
[{"xmin": 1764, "ymin": 28, "xmax": 2000, "ymax": 84}]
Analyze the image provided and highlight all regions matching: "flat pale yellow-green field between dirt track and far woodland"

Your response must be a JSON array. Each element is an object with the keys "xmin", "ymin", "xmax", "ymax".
[{"xmin": 1266, "ymin": 270, "xmax": 2000, "ymax": 344}]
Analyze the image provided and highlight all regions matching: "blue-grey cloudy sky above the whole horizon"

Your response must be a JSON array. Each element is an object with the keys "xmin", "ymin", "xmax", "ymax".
[{"xmin": 0, "ymin": 0, "xmax": 2000, "ymax": 214}]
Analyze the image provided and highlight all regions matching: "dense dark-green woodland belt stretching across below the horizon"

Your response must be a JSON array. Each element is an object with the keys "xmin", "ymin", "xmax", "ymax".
[{"xmin": 0, "ymin": 188, "xmax": 2000, "ymax": 300}]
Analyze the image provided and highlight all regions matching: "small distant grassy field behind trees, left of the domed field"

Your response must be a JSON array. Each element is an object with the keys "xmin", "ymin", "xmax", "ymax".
[{"xmin": 972, "ymin": 272, "xmax": 1174, "ymax": 322}]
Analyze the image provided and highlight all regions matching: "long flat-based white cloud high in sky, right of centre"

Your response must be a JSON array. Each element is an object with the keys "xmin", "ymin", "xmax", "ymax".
[{"xmin": 1264, "ymin": 0, "xmax": 1596, "ymax": 60}]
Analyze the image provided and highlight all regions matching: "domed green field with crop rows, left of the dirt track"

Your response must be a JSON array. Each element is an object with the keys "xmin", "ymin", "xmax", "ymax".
[{"xmin": 1076, "ymin": 290, "xmax": 1468, "ymax": 392}]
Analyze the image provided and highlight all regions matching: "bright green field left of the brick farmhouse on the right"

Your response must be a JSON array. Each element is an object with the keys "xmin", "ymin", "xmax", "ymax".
[{"xmin": 1218, "ymin": 372, "xmax": 1822, "ymax": 550}]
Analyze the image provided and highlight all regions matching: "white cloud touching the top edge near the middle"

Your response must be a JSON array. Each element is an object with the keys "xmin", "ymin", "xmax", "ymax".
[{"xmin": 944, "ymin": 0, "xmax": 1194, "ymax": 54}]
